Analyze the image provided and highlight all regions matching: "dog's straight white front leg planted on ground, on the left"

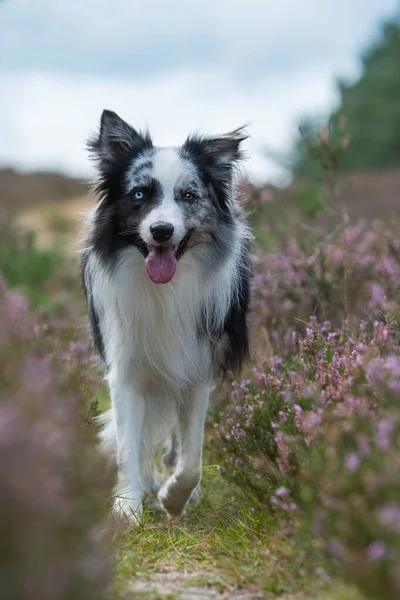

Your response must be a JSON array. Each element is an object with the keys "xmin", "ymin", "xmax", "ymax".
[{"xmin": 108, "ymin": 372, "xmax": 145, "ymax": 521}]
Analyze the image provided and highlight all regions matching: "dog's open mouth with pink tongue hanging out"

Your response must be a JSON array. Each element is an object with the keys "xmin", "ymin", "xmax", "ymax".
[{"xmin": 138, "ymin": 230, "xmax": 193, "ymax": 283}]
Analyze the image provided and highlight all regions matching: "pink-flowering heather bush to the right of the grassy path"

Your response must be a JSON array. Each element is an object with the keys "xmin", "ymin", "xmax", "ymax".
[{"xmin": 213, "ymin": 223, "xmax": 400, "ymax": 600}]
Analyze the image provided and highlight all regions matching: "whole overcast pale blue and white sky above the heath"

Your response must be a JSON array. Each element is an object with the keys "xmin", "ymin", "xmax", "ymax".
[{"xmin": 0, "ymin": 0, "xmax": 399, "ymax": 182}]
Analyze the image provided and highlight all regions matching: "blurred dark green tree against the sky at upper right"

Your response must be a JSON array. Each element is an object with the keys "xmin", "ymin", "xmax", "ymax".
[{"xmin": 293, "ymin": 19, "xmax": 400, "ymax": 175}]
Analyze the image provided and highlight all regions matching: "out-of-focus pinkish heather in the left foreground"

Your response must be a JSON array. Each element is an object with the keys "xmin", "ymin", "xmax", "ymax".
[{"xmin": 0, "ymin": 281, "xmax": 112, "ymax": 600}]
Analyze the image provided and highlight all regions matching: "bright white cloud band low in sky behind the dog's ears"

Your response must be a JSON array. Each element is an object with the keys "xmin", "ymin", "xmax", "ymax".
[{"xmin": 0, "ymin": 70, "xmax": 338, "ymax": 181}]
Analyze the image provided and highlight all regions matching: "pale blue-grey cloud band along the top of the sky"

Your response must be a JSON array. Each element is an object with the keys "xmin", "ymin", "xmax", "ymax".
[{"xmin": 0, "ymin": 0, "xmax": 397, "ymax": 80}]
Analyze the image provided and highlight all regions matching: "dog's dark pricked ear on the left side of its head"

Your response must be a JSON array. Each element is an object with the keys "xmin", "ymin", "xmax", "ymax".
[{"xmin": 87, "ymin": 110, "xmax": 153, "ymax": 175}]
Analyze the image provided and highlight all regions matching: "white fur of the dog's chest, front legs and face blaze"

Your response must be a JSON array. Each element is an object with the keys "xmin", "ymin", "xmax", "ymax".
[{"xmin": 88, "ymin": 214, "xmax": 248, "ymax": 518}]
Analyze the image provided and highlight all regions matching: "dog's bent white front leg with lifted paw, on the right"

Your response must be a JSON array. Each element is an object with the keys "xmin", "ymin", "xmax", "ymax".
[{"xmin": 158, "ymin": 385, "xmax": 210, "ymax": 517}]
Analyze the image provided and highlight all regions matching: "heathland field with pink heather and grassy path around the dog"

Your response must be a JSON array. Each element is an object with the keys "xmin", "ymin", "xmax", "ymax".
[{"xmin": 0, "ymin": 161, "xmax": 400, "ymax": 600}]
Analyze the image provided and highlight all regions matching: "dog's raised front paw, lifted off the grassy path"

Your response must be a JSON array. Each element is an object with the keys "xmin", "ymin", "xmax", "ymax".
[{"xmin": 158, "ymin": 474, "xmax": 199, "ymax": 519}]
